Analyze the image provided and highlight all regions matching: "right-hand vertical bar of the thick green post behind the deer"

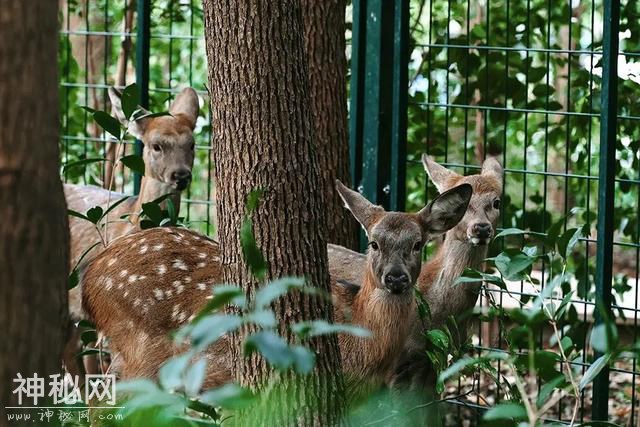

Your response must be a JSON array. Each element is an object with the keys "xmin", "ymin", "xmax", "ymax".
[{"xmin": 390, "ymin": 0, "xmax": 409, "ymax": 211}]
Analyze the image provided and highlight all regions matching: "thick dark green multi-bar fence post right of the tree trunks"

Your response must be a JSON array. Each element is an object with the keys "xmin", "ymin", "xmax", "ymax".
[{"xmin": 349, "ymin": 0, "xmax": 409, "ymax": 247}]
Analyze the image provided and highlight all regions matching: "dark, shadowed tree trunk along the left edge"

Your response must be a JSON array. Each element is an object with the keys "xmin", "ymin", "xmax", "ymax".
[{"xmin": 0, "ymin": 0, "xmax": 69, "ymax": 425}]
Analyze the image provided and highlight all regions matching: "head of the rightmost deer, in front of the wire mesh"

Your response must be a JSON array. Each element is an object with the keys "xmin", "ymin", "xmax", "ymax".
[{"xmin": 422, "ymin": 155, "xmax": 503, "ymax": 246}]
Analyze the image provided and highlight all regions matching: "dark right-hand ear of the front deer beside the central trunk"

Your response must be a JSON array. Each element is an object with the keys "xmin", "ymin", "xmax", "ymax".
[{"xmin": 418, "ymin": 184, "xmax": 473, "ymax": 237}]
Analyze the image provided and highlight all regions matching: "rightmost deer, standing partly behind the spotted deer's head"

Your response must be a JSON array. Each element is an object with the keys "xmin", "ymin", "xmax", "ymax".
[{"xmin": 327, "ymin": 155, "xmax": 503, "ymax": 416}]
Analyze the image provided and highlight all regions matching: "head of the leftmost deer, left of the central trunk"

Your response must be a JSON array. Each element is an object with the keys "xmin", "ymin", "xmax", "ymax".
[{"xmin": 109, "ymin": 88, "xmax": 199, "ymax": 191}]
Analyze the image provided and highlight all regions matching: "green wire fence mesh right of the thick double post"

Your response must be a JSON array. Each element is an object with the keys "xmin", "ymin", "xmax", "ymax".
[{"xmin": 407, "ymin": 0, "xmax": 640, "ymax": 425}]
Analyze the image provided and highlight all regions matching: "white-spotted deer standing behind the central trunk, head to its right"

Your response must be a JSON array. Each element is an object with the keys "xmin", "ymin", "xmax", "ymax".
[{"xmin": 81, "ymin": 182, "xmax": 472, "ymax": 402}]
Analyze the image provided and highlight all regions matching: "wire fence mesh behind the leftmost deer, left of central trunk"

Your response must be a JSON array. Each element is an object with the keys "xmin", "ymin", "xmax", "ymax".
[{"xmin": 59, "ymin": 0, "xmax": 215, "ymax": 234}]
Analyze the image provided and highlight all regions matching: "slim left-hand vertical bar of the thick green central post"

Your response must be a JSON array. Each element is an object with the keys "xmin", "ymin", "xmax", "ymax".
[{"xmin": 349, "ymin": 0, "xmax": 367, "ymax": 191}]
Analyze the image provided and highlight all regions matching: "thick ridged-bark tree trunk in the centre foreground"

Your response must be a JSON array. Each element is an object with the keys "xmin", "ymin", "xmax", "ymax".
[{"xmin": 203, "ymin": 0, "xmax": 344, "ymax": 425}]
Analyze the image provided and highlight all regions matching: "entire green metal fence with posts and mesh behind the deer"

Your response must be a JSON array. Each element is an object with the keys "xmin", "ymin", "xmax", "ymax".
[{"xmin": 60, "ymin": 0, "xmax": 640, "ymax": 425}]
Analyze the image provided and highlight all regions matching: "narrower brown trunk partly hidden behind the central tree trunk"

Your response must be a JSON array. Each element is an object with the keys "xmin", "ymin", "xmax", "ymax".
[{"xmin": 301, "ymin": 0, "xmax": 359, "ymax": 250}]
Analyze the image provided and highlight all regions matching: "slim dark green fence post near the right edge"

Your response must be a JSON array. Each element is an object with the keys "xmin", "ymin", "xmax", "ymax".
[{"xmin": 591, "ymin": 0, "xmax": 620, "ymax": 421}]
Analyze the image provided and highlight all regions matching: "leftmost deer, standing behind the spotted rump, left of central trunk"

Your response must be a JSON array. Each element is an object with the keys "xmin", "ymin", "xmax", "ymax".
[{"xmin": 64, "ymin": 87, "xmax": 199, "ymax": 373}]
